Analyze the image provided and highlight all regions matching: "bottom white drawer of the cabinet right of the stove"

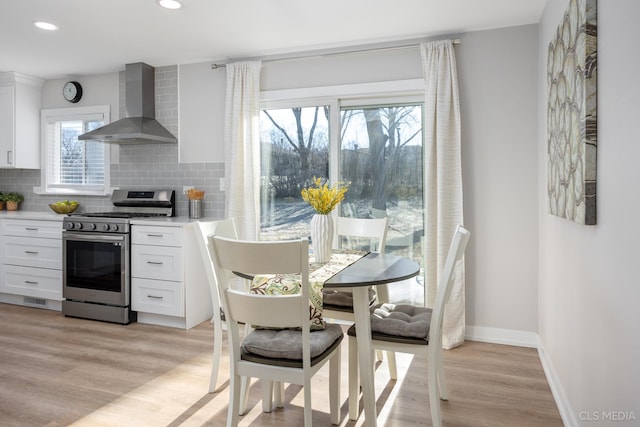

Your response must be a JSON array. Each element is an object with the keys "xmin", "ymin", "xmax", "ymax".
[{"xmin": 131, "ymin": 278, "xmax": 184, "ymax": 317}]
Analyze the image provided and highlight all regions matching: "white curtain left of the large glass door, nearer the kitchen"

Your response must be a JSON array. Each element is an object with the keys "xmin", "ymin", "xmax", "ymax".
[{"xmin": 224, "ymin": 61, "xmax": 262, "ymax": 240}]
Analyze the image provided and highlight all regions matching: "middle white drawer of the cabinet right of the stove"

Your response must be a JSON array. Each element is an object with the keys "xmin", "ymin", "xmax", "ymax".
[{"xmin": 131, "ymin": 245, "xmax": 182, "ymax": 282}]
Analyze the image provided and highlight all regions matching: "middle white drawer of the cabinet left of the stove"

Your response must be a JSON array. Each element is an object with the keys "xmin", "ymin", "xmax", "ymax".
[{"xmin": 2, "ymin": 236, "xmax": 62, "ymax": 270}]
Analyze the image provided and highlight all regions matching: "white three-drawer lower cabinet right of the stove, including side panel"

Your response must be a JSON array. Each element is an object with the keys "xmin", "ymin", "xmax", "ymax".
[{"xmin": 131, "ymin": 222, "xmax": 213, "ymax": 329}]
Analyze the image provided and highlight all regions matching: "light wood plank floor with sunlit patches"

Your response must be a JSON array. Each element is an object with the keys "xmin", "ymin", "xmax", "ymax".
[{"xmin": 0, "ymin": 304, "xmax": 562, "ymax": 427}]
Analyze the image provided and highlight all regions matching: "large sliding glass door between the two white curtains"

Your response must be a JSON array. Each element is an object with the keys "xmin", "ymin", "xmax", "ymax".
[{"xmin": 260, "ymin": 90, "xmax": 424, "ymax": 304}]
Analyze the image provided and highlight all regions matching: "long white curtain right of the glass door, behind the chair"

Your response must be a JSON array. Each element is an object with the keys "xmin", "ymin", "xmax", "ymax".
[{"xmin": 420, "ymin": 40, "xmax": 465, "ymax": 349}]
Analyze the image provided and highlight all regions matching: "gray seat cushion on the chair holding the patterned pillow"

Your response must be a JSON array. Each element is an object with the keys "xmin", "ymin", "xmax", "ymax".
[{"xmin": 242, "ymin": 323, "xmax": 344, "ymax": 360}]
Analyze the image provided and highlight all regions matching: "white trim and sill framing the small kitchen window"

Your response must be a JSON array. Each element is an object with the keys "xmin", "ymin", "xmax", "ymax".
[{"xmin": 33, "ymin": 105, "xmax": 112, "ymax": 196}]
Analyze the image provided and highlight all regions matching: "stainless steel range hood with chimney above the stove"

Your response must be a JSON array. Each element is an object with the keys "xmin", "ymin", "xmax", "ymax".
[{"xmin": 78, "ymin": 62, "xmax": 178, "ymax": 144}]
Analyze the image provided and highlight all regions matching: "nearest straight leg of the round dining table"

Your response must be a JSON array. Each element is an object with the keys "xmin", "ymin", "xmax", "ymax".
[{"xmin": 352, "ymin": 286, "xmax": 377, "ymax": 427}]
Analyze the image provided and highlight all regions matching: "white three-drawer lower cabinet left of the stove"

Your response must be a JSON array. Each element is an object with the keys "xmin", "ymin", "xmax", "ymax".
[{"xmin": 0, "ymin": 219, "xmax": 62, "ymax": 310}]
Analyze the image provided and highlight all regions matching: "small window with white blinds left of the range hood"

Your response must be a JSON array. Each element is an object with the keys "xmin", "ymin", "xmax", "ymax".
[{"xmin": 42, "ymin": 106, "xmax": 109, "ymax": 194}]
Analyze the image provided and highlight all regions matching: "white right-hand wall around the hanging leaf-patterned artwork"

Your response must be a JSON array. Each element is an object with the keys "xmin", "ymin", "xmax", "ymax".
[{"xmin": 538, "ymin": 0, "xmax": 640, "ymax": 426}]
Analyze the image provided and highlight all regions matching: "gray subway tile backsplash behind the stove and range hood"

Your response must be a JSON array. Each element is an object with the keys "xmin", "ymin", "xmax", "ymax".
[{"xmin": 0, "ymin": 66, "xmax": 224, "ymax": 218}]
